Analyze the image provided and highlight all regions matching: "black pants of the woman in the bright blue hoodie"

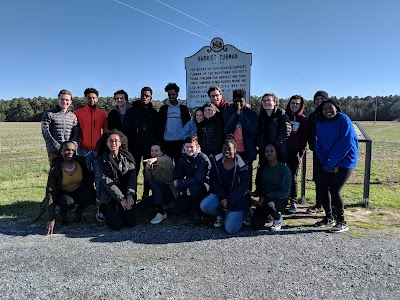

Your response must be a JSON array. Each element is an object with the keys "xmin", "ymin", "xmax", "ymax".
[{"xmin": 317, "ymin": 167, "xmax": 353, "ymax": 222}]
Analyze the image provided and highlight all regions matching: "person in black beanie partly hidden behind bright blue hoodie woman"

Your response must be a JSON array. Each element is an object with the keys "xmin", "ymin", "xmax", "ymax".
[{"xmin": 307, "ymin": 91, "xmax": 330, "ymax": 213}]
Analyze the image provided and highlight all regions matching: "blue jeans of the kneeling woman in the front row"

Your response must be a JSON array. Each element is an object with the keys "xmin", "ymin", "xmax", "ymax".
[{"xmin": 200, "ymin": 194, "xmax": 248, "ymax": 233}]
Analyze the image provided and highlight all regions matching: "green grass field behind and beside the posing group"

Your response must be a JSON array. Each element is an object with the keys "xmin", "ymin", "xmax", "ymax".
[{"xmin": 0, "ymin": 122, "xmax": 400, "ymax": 234}]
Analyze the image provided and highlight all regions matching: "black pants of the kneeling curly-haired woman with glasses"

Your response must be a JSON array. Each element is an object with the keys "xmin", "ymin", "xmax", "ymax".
[{"xmin": 100, "ymin": 199, "xmax": 136, "ymax": 230}]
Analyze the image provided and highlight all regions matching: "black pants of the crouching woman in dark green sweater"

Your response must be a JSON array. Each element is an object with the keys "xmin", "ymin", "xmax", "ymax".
[{"xmin": 251, "ymin": 198, "xmax": 288, "ymax": 230}]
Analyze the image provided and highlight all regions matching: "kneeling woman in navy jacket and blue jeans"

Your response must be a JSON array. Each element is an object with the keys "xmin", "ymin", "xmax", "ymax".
[{"xmin": 200, "ymin": 136, "xmax": 251, "ymax": 233}]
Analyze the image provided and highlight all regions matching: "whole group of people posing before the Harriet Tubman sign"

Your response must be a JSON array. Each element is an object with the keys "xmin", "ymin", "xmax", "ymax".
[{"xmin": 41, "ymin": 83, "xmax": 358, "ymax": 234}]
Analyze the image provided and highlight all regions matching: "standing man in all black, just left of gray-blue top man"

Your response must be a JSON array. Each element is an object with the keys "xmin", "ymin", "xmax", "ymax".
[{"xmin": 122, "ymin": 86, "xmax": 161, "ymax": 200}]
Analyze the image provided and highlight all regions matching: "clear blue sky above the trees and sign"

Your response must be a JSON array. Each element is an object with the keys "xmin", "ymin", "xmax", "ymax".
[{"xmin": 0, "ymin": 0, "xmax": 400, "ymax": 100}]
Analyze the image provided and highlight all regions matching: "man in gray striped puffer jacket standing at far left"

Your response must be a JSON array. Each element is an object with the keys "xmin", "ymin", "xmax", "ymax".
[{"xmin": 41, "ymin": 90, "xmax": 79, "ymax": 166}]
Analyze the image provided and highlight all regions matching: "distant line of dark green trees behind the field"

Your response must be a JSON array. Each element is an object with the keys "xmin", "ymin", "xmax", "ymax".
[{"xmin": 0, "ymin": 95, "xmax": 400, "ymax": 122}]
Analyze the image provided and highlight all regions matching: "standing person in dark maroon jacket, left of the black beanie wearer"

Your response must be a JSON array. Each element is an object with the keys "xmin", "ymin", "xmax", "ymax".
[{"xmin": 285, "ymin": 95, "xmax": 308, "ymax": 214}]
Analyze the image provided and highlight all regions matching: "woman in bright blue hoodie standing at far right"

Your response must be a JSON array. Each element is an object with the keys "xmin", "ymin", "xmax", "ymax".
[{"xmin": 315, "ymin": 99, "xmax": 358, "ymax": 232}]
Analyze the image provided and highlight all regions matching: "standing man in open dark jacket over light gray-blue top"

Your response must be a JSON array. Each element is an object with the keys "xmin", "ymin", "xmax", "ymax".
[{"xmin": 159, "ymin": 82, "xmax": 191, "ymax": 162}]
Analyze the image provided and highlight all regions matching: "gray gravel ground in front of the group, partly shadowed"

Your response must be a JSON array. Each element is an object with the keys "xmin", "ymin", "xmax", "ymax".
[{"xmin": 0, "ymin": 219, "xmax": 400, "ymax": 299}]
